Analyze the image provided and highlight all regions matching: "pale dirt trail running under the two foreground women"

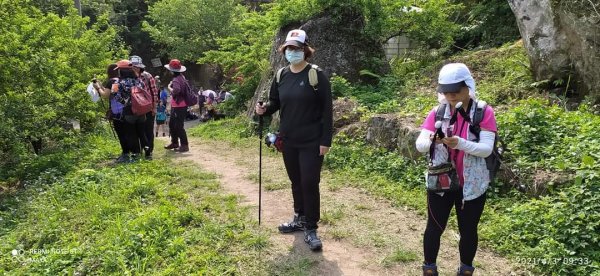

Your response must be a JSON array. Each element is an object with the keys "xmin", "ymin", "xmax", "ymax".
[{"xmin": 159, "ymin": 128, "xmax": 520, "ymax": 275}]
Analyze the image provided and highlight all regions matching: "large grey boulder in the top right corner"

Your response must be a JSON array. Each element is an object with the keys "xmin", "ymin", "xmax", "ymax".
[{"xmin": 508, "ymin": 0, "xmax": 600, "ymax": 102}]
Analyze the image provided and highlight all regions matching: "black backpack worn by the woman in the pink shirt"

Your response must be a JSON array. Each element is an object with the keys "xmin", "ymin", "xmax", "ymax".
[{"xmin": 435, "ymin": 101, "xmax": 504, "ymax": 183}]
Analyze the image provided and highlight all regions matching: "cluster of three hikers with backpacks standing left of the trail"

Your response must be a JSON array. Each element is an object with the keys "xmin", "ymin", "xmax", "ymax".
[{"xmin": 94, "ymin": 56, "xmax": 198, "ymax": 160}]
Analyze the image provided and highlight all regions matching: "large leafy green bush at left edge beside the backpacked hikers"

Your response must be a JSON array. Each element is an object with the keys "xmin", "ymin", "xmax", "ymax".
[{"xmin": 0, "ymin": 0, "xmax": 124, "ymax": 179}]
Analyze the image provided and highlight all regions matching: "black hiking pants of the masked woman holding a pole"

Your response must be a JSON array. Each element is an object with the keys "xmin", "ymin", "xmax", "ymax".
[{"xmin": 283, "ymin": 142, "xmax": 323, "ymax": 230}]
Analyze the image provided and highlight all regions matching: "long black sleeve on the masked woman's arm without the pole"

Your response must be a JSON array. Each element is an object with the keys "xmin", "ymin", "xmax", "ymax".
[{"xmin": 317, "ymin": 70, "xmax": 333, "ymax": 147}]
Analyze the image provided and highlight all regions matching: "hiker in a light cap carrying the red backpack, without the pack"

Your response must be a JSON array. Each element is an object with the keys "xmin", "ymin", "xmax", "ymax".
[{"xmin": 130, "ymin": 56, "xmax": 158, "ymax": 160}]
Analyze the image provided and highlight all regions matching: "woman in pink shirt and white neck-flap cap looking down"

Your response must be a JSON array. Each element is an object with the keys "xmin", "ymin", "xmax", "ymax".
[{"xmin": 416, "ymin": 63, "xmax": 497, "ymax": 275}]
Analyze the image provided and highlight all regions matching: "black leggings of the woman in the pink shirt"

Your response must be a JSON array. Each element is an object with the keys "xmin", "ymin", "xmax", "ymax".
[{"xmin": 423, "ymin": 190, "xmax": 486, "ymax": 266}]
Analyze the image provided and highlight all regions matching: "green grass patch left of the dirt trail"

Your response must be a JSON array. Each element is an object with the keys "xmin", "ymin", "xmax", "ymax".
[{"xmin": 0, "ymin": 134, "xmax": 268, "ymax": 275}]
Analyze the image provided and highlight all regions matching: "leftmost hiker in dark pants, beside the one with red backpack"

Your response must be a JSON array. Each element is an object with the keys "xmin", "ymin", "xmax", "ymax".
[{"xmin": 112, "ymin": 59, "xmax": 148, "ymax": 161}]
